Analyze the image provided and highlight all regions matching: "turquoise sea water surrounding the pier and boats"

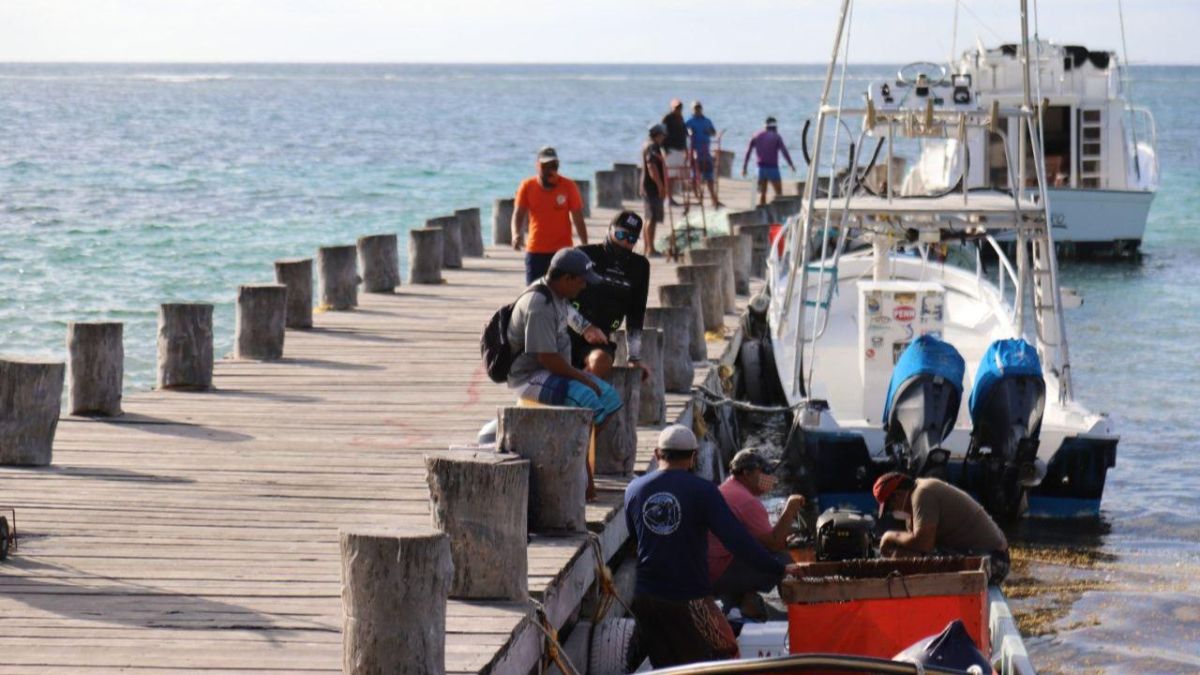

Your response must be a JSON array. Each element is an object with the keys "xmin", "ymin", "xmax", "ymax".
[{"xmin": 0, "ymin": 65, "xmax": 1200, "ymax": 671}]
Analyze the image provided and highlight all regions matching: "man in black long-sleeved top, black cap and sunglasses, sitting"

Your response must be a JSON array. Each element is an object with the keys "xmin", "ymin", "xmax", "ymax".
[{"xmin": 571, "ymin": 211, "xmax": 650, "ymax": 377}]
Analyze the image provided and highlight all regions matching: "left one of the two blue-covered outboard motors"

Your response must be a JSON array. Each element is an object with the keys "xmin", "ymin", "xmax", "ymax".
[{"xmin": 883, "ymin": 335, "xmax": 966, "ymax": 478}]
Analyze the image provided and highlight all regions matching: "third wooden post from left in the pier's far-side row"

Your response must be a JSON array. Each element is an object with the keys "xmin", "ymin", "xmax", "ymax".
[{"xmin": 157, "ymin": 303, "xmax": 212, "ymax": 390}]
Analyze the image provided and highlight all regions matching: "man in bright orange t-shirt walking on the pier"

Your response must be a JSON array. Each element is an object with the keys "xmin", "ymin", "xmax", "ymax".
[{"xmin": 512, "ymin": 148, "xmax": 588, "ymax": 285}]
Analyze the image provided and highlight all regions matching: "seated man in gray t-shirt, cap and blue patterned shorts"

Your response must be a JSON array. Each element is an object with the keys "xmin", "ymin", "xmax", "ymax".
[{"xmin": 508, "ymin": 249, "xmax": 622, "ymax": 425}]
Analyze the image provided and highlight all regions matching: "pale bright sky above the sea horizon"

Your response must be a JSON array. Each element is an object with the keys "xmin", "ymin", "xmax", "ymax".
[{"xmin": 0, "ymin": 0, "xmax": 1200, "ymax": 64}]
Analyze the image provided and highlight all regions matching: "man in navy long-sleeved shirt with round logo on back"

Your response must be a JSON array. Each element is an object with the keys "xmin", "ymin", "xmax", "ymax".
[{"xmin": 625, "ymin": 424, "xmax": 798, "ymax": 668}]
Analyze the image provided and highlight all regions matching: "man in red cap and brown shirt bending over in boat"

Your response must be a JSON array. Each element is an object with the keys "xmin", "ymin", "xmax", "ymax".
[{"xmin": 871, "ymin": 471, "xmax": 1009, "ymax": 585}]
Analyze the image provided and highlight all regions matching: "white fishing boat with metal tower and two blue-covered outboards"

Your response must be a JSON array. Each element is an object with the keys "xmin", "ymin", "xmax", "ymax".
[{"xmin": 768, "ymin": 22, "xmax": 1117, "ymax": 519}]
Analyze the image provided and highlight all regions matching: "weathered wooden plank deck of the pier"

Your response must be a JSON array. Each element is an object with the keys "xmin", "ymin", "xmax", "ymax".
[{"xmin": 0, "ymin": 176, "xmax": 787, "ymax": 673}]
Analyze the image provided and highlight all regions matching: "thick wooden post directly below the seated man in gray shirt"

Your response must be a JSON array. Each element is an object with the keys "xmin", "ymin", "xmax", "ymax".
[{"xmin": 496, "ymin": 406, "xmax": 592, "ymax": 532}]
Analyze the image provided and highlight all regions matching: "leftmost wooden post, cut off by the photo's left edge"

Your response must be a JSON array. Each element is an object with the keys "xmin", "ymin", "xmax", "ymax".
[{"xmin": 0, "ymin": 355, "xmax": 65, "ymax": 466}]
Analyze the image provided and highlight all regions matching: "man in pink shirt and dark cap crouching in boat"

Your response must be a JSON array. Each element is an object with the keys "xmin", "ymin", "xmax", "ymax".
[{"xmin": 708, "ymin": 449, "xmax": 804, "ymax": 619}]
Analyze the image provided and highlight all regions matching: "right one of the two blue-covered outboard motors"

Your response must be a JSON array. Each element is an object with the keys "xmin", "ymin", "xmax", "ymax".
[{"xmin": 964, "ymin": 339, "xmax": 1046, "ymax": 521}]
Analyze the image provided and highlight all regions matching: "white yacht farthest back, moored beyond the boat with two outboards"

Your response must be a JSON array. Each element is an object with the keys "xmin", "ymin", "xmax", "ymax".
[{"xmin": 901, "ymin": 40, "xmax": 1158, "ymax": 256}]
